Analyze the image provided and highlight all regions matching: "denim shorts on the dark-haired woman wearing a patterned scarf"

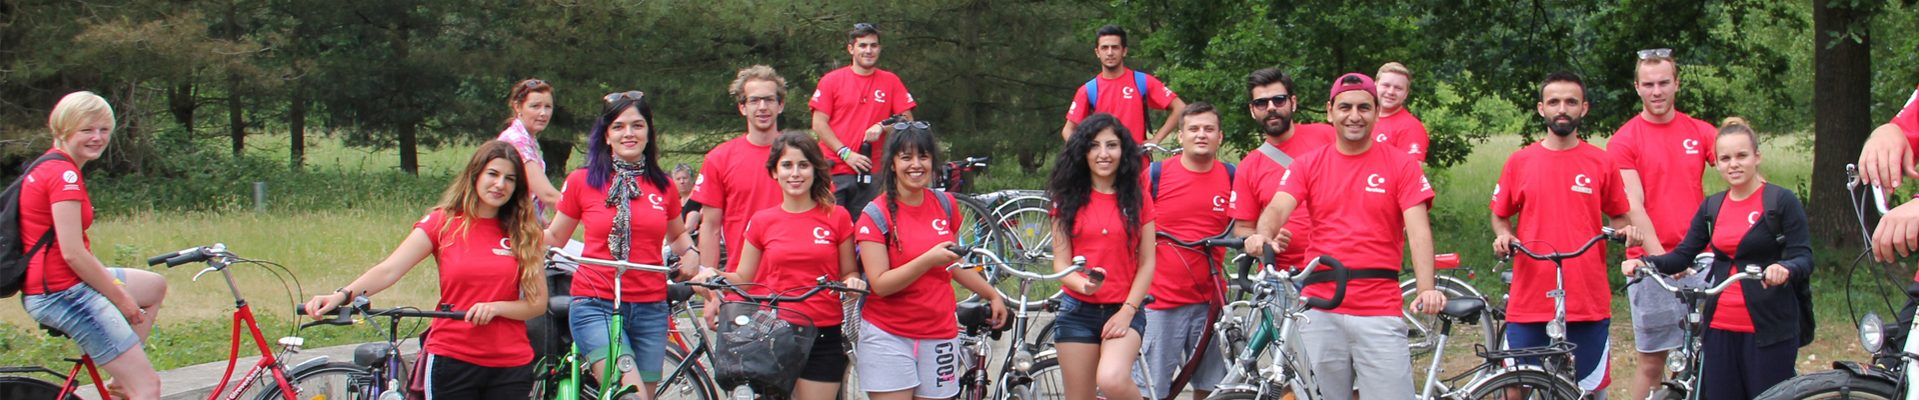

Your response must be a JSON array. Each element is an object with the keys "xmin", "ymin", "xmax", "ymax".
[{"xmin": 566, "ymin": 296, "xmax": 668, "ymax": 383}]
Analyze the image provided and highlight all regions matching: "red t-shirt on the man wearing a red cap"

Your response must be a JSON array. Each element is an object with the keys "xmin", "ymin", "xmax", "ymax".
[{"xmin": 1280, "ymin": 146, "xmax": 1433, "ymax": 315}]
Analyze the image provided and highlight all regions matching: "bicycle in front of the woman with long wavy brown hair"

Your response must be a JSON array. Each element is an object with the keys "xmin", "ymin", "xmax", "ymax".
[{"xmin": 282, "ymin": 296, "xmax": 466, "ymax": 400}]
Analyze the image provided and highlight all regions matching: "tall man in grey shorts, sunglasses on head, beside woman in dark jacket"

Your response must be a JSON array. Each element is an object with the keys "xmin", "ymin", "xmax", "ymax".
[{"xmin": 1606, "ymin": 48, "xmax": 1719, "ymax": 398}]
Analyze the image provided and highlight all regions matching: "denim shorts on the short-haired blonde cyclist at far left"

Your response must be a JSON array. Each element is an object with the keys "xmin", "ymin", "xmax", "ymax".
[{"xmin": 25, "ymin": 269, "xmax": 140, "ymax": 365}]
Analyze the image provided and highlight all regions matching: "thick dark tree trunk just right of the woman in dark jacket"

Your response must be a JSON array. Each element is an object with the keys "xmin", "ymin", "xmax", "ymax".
[{"xmin": 1808, "ymin": 2, "xmax": 1873, "ymax": 246}]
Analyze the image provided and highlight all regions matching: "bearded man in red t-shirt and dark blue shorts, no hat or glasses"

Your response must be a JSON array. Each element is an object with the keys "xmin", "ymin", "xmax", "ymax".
[{"xmin": 1491, "ymin": 71, "xmax": 1631, "ymax": 398}]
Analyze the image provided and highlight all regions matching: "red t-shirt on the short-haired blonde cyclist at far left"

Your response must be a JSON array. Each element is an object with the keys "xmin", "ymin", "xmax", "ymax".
[{"xmin": 19, "ymin": 148, "xmax": 94, "ymax": 294}]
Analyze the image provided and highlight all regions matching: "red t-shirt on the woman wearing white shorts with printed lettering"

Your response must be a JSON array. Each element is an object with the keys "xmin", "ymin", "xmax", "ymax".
[{"xmin": 854, "ymin": 190, "xmax": 963, "ymax": 340}]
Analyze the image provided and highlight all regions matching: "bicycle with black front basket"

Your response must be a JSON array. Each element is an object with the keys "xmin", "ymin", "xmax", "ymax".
[{"xmin": 687, "ymin": 277, "xmax": 867, "ymax": 400}]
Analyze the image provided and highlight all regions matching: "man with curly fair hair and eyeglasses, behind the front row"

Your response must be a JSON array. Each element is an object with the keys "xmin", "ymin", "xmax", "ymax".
[{"xmin": 693, "ymin": 65, "xmax": 787, "ymax": 279}]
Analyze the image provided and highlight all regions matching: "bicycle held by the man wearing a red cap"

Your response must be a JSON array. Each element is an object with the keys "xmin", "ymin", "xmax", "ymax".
[{"xmin": 1207, "ymin": 246, "xmax": 1349, "ymax": 400}]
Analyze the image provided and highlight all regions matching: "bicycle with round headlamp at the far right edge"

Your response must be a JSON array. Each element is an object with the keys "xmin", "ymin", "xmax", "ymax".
[{"xmin": 1758, "ymin": 163, "xmax": 1919, "ymax": 400}]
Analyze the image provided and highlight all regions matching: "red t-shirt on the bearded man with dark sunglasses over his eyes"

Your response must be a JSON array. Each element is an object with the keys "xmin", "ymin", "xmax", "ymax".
[{"xmin": 1226, "ymin": 123, "xmax": 1336, "ymax": 271}]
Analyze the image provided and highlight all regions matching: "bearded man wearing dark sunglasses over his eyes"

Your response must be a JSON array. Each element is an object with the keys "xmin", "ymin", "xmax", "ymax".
[{"xmin": 1228, "ymin": 67, "xmax": 1334, "ymax": 271}]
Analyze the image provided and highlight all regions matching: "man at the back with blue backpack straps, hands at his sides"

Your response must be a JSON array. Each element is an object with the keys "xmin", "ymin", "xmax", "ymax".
[{"xmin": 1059, "ymin": 25, "xmax": 1186, "ymax": 144}]
